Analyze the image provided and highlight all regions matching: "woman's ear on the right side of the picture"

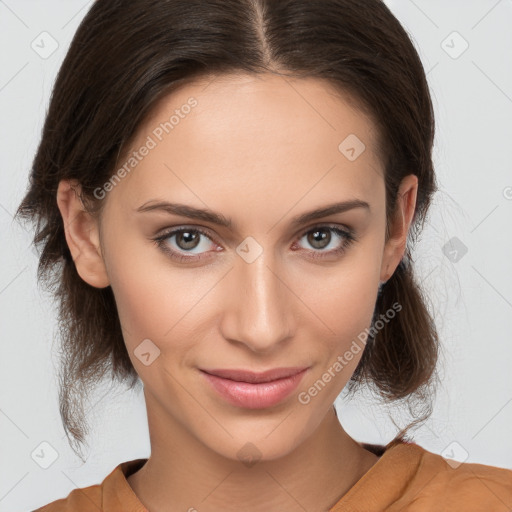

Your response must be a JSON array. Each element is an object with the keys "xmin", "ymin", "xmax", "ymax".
[{"xmin": 380, "ymin": 174, "xmax": 418, "ymax": 282}]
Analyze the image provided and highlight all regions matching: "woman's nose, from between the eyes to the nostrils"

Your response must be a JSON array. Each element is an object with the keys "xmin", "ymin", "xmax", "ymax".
[{"xmin": 222, "ymin": 251, "xmax": 298, "ymax": 353}]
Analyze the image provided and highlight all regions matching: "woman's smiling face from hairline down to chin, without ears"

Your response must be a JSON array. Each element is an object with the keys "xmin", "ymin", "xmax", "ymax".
[{"xmin": 68, "ymin": 75, "xmax": 415, "ymax": 460}]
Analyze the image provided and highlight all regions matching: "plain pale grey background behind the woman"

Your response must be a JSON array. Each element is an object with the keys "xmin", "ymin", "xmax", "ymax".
[{"xmin": 0, "ymin": 0, "xmax": 512, "ymax": 512}]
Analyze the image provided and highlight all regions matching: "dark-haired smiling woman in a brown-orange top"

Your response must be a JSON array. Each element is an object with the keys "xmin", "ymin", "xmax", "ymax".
[{"xmin": 18, "ymin": 0, "xmax": 512, "ymax": 512}]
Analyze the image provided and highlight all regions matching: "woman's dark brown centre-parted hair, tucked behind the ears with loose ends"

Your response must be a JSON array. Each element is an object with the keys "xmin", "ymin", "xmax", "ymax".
[{"xmin": 16, "ymin": 0, "xmax": 439, "ymax": 458}]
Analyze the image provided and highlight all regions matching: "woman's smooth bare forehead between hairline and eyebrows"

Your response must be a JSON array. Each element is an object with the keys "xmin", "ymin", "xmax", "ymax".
[{"xmin": 112, "ymin": 74, "xmax": 382, "ymax": 210}]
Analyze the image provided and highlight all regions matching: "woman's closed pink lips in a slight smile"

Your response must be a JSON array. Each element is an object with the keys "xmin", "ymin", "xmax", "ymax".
[{"xmin": 200, "ymin": 367, "xmax": 309, "ymax": 409}]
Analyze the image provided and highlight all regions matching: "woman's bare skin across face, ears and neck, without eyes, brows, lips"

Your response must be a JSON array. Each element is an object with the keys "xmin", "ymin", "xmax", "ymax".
[{"xmin": 57, "ymin": 75, "xmax": 417, "ymax": 512}]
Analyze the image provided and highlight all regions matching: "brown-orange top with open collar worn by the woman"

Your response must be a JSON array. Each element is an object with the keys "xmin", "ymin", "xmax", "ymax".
[{"xmin": 35, "ymin": 440, "xmax": 512, "ymax": 512}]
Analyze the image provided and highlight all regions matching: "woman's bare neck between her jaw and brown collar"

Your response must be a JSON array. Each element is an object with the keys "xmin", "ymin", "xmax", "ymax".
[{"xmin": 128, "ymin": 400, "xmax": 378, "ymax": 512}]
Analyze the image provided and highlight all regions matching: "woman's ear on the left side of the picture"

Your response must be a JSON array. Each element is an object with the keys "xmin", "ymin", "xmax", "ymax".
[{"xmin": 57, "ymin": 180, "xmax": 110, "ymax": 288}]
